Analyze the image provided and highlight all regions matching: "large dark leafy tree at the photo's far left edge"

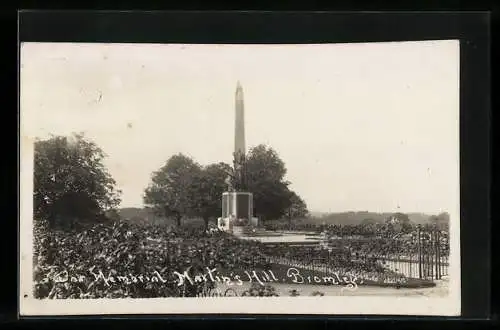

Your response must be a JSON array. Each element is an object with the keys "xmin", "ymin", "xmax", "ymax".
[{"xmin": 33, "ymin": 134, "xmax": 120, "ymax": 226}]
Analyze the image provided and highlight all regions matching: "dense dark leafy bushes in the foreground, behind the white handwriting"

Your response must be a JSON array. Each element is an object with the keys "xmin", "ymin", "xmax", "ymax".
[{"xmin": 34, "ymin": 222, "xmax": 438, "ymax": 299}]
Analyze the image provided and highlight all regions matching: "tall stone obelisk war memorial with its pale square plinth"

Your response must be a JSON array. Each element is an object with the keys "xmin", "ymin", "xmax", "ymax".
[{"xmin": 218, "ymin": 81, "xmax": 257, "ymax": 235}]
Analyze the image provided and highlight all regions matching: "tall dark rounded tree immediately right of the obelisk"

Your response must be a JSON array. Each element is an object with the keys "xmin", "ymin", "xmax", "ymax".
[{"xmin": 245, "ymin": 145, "xmax": 300, "ymax": 221}]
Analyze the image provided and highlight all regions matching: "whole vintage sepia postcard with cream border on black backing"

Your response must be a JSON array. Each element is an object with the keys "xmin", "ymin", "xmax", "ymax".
[{"xmin": 19, "ymin": 40, "xmax": 460, "ymax": 316}]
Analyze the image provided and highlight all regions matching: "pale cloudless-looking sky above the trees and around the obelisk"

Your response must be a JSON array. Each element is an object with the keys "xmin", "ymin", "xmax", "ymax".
[{"xmin": 21, "ymin": 41, "xmax": 459, "ymax": 213}]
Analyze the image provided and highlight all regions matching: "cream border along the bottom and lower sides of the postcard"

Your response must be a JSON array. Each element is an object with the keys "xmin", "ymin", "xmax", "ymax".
[{"xmin": 19, "ymin": 41, "xmax": 461, "ymax": 316}]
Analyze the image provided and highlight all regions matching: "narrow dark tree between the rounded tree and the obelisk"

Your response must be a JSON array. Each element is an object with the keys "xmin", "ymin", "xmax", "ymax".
[{"xmin": 194, "ymin": 163, "xmax": 231, "ymax": 228}]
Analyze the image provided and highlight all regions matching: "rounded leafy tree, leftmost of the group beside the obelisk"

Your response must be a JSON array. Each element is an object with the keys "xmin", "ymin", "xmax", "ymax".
[{"xmin": 144, "ymin": 154, "xmax": 202, "ymax": 226}]
